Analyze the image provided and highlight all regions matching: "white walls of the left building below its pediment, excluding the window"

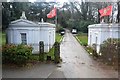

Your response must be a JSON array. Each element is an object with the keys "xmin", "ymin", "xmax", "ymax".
[{"xmin": 6, "ymin": 22, "xmax": 55, "ymax": 53}]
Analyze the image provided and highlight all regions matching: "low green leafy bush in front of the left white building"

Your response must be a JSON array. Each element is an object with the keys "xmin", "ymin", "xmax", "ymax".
[{"xmin": 2, "ymin": 44, "xmax": 32, "ymax": 65}]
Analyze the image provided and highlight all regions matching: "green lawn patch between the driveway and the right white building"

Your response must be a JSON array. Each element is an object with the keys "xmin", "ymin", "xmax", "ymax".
[{"xmin": 76, "ymin": 33, "xmax": 88, "ymax": 46}]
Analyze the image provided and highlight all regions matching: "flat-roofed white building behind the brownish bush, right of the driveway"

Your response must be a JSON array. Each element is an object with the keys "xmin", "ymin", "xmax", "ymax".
[{"xmin": 88, "ymin": 23, "xmax": 120, "ymax": 53}]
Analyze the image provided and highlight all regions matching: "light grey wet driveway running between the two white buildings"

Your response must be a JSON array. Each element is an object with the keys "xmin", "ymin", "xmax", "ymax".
[{"xmin": 61, "ymin": 31, "xmax": 118, "ymax": 78}]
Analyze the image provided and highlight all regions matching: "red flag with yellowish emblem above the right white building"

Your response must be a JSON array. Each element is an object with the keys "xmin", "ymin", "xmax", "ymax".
[{"xmin": 99, "ymin": 6, "xmax": 112, "ymax": 17}]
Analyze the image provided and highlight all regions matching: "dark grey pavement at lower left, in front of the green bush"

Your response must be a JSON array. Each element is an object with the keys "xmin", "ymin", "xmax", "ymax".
[{"xmin": 2, "ymin": 63, "xmax": 56, "ymax": 78}]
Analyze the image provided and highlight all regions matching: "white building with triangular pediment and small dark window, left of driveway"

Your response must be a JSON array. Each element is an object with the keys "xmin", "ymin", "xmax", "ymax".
[{"xmin": 6, "ymin": 13, "xmax": 55, "ymax": 53}]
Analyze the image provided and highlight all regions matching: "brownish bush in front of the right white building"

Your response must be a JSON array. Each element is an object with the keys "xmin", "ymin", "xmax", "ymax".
[{"xmin": 100, "ymin": 39, "xmax": 120, "ymax": 65}]
